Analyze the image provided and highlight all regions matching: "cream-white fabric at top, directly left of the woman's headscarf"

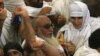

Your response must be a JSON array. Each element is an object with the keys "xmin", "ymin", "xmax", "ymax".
[{"xmin": 50, "ymin": 0, "xmax": 69, "ymax": 21}]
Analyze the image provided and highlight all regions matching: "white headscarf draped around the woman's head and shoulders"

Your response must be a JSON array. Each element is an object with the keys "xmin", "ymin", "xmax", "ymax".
[{"xmin": 57, "ymin": 1, "xmax": 91, "ymax": 49}]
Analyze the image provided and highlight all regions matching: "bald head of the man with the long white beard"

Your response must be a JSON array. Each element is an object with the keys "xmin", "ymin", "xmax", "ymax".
[{"xmin": 36, "ymin": 16, "xmax": 53, "ymax": 37}]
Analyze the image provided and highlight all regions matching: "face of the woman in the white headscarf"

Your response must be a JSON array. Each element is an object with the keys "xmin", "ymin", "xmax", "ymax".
[{"xmin": 71, "ymin": 17, "xmax": 83, "ymax": 29}]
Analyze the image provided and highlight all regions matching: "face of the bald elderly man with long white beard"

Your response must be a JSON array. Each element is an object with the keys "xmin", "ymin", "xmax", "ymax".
[{"xmin": 39, "ymin": 17, "xmax": 53, "ymax": 37}]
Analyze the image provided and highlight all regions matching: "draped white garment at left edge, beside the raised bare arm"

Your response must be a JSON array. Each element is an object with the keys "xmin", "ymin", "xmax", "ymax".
[{"xmin": 0, "ymin": 10, "xmax": 21, "ymax": 47}]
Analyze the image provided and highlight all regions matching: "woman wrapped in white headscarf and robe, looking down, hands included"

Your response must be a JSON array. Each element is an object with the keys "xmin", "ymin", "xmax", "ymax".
[{"xmin": 57, "ymin": 1, "xmax": 100, "ymax": 53}]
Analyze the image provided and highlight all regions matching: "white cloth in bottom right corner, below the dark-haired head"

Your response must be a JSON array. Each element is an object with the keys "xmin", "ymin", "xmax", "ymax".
[{"xmin": 74, "ymin": 46, "xmax": 100, "ymax": 56}]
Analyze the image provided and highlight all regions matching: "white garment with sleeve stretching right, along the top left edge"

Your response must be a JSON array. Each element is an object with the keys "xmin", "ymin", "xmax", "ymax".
[{"xmin": 4, "ymin": 0, "xmax": 50, "ymax": 17}]
